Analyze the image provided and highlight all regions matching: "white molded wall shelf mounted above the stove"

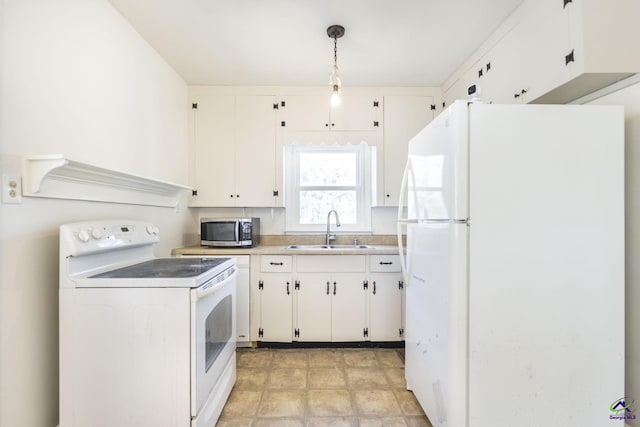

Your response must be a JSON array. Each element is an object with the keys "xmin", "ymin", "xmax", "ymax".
[{"xmin": 22, "ymin": 155, "xmax": 193, "ymax": 207}]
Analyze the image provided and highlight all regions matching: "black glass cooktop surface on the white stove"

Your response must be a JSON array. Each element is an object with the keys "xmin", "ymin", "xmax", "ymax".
[{"xmin": 89, "ymin": 258, "xmax": 230, "ymax": 279}]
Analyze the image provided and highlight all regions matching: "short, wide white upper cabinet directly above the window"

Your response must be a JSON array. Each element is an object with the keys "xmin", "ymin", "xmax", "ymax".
[{"xmin": 278, "ymin": 94, "xmax": 379, "ymax": 132}]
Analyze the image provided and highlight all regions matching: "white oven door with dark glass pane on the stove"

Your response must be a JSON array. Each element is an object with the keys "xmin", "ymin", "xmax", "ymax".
[{"xmin": 191, "ymin": 267, "xmax": 238, "ymax": 417}]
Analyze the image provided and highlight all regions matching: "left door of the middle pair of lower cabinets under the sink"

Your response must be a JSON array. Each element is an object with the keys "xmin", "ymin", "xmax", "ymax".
[{"xmin": 296, "ymin": 274, "xmax": 333, "ymax": 341}]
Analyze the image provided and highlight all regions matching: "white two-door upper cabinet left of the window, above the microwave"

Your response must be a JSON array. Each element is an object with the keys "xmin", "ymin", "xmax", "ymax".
[{"xmin": 191, "ymin": 95, "xmax": 281, "ymax": 207}]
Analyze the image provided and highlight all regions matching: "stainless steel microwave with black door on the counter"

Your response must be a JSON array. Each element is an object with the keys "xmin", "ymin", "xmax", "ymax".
[{"xmin": 200, "ymin": 218, "xmax": 260, "ymax": 248}]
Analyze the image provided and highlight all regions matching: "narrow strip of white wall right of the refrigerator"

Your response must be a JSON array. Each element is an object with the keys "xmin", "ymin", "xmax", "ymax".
[{"xmin": 585, "ymin": 76, "xmax": 640, "ymax": 426}]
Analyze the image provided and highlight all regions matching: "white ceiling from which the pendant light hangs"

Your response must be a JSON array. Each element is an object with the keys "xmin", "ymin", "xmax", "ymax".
[{"xmin": 110, "ymin": 0, "xmax": 523, "ymax": 87}]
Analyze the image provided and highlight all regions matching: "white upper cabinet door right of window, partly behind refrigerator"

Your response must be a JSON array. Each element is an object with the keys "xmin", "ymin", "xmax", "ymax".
[{"xmin": 380, "ymin": 95, "xmax": 435, "ymax": 206}]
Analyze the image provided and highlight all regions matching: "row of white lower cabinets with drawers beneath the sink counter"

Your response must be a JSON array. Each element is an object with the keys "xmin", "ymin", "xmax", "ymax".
[{"xmin": 252, "ymin": 255, "xmax": 403, "ymax": 342}]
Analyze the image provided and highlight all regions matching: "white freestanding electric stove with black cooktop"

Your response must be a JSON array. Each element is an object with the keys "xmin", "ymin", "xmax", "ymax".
[{"xmin": 60, "ymin": 220, "xmax": 237, "ymax": 427}]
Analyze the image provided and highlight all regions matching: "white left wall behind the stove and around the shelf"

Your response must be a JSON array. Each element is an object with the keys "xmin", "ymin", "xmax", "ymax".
[{"xmin": 0, "ymin": 0, "xmax": 196, "ymax": 427}]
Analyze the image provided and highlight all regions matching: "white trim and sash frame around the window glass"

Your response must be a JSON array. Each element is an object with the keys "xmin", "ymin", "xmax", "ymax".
[{"xmin": 284, "ymin": 142, "xmax": 375, "ymax": 234}]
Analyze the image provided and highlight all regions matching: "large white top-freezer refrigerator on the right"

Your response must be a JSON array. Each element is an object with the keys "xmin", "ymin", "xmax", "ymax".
[{"xmin": 398, "ymin": 101, "xmax": 625, "ymax": 427}]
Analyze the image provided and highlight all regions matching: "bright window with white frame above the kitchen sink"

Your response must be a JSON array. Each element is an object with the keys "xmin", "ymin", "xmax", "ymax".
[{"xmin": 285, "ymin": 143, "xmax": 374, "ymax": 232}]
